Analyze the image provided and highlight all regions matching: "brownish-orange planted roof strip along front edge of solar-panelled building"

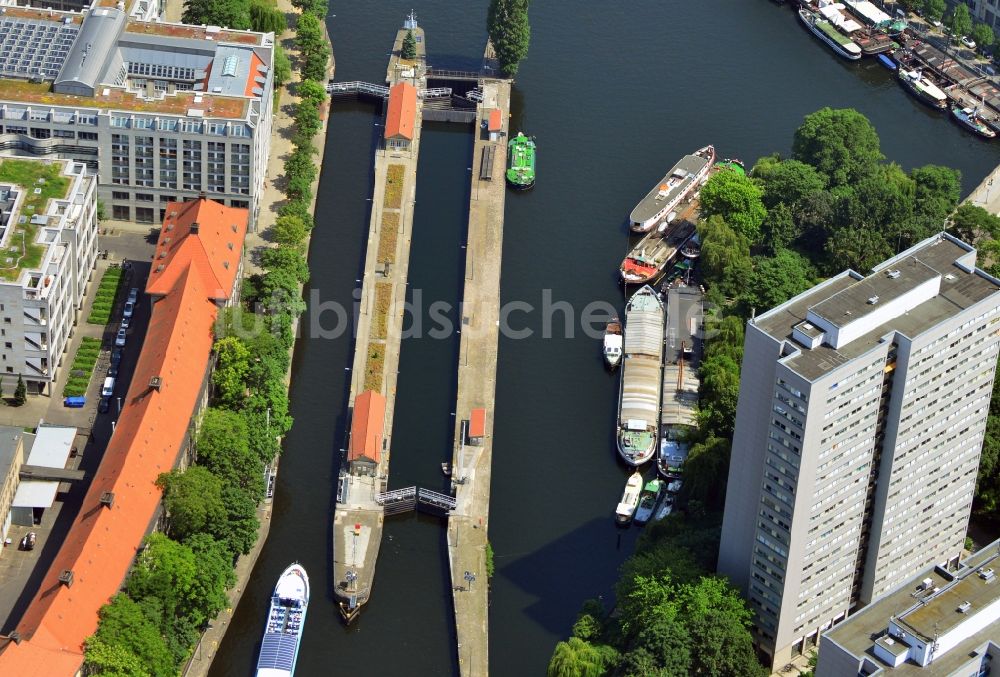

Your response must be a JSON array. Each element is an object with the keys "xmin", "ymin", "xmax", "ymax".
[{"xmin": 0, "ymin": 78, "xmax": 249, "ymax": 119}]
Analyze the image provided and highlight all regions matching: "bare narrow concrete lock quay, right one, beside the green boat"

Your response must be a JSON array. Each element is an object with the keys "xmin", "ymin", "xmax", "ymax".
[{"xmin": 448, "ymin": 79, "xmax": 510, "ymax": 677}]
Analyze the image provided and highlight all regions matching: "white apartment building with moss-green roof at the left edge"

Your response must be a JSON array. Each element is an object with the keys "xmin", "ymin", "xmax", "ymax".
[{"xmin": 0, "ymin": 158, "xmax": 97, "ymax": 393}]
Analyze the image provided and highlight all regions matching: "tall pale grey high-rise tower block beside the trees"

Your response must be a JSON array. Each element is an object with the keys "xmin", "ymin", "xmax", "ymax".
[{"xmin": 719, "ymin": 233, "xmax": 1000, "ymax": 668}]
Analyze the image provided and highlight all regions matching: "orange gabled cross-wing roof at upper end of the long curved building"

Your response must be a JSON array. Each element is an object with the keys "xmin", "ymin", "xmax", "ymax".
[{"xmin": 146, "ymin": 197, "xmax": 250, "ymax": 301}]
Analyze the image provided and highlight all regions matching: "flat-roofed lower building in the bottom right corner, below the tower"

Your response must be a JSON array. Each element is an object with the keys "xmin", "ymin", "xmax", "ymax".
[{"xmin": 816, "ymin": 541, "xmax": 1000, "ymax": 677}]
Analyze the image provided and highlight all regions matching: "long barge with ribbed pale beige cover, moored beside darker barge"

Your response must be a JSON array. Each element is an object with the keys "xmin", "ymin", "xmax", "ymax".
[{"xmin": 617, "ymin": 285, "xmax": 665, "ymax": 466}]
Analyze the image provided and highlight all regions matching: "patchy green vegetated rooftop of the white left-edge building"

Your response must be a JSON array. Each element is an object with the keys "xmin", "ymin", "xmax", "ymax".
[{"xmin": 0, "ymin": 158, "xmax": 70, "ymax": 282}]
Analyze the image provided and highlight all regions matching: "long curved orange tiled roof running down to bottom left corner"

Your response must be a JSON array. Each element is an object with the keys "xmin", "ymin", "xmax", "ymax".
[{"xmin": 0, "ymin": 198, "xmax": 244, "ymax": 677}]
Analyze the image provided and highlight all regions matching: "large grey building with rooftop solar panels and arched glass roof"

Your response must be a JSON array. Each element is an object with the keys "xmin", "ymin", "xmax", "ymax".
[{"xmin": 0, "ymin": 3, "xmax": 274, "ymax": 224}]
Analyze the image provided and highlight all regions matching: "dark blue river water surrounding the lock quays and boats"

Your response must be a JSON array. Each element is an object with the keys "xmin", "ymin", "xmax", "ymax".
[{"xmin": 211, "ymin": 0, "xmax": 1000, "ymax": 677}]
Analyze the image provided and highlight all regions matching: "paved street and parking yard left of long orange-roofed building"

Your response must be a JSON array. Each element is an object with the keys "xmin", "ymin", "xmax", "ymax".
[{"xmin": 0, "ymin": 229, "xmax": 156, "ymax": 634}]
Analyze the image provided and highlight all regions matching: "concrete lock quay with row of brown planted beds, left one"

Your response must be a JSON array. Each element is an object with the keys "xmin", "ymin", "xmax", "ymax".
[{"xmin": 332, "ymin": 19, "xmax": 426, "ymax": 622}]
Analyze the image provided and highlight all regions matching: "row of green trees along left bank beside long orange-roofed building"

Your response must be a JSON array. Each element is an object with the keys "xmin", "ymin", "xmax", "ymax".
[{"xmin": 85, "ymin": 3, "xmax": 329, "ymax": 677}]
